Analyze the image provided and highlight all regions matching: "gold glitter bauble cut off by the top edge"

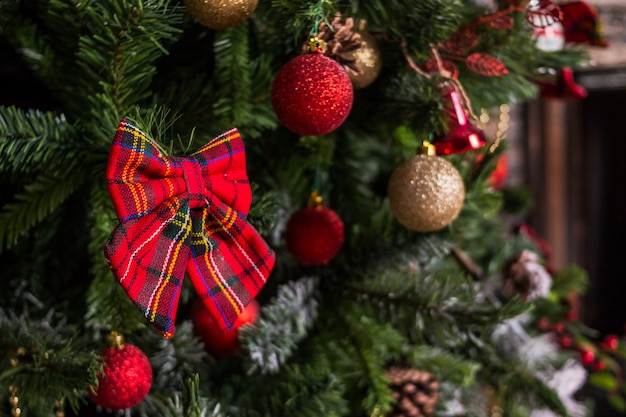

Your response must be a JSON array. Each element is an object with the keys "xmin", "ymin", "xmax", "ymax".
[{"xmin": 184, "ymin": 0, "xmax": 258, "ymax": 29}]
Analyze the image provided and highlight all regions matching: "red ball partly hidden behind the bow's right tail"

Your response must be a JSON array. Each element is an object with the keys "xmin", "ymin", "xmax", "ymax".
[{"xmin": 191, "ymin": 299, "xmax": 261, "ymax": 356}]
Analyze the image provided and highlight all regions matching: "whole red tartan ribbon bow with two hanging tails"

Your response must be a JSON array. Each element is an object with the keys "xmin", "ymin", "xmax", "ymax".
[{"xmin": 104, "ymin": 120, "xmax": 274, "ymax": 337}]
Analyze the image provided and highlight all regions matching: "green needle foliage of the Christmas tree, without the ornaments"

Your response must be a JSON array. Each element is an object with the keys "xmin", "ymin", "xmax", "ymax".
[{"xmin": 0, "ymin": 0, "xmax": 596, "ymax": 417}]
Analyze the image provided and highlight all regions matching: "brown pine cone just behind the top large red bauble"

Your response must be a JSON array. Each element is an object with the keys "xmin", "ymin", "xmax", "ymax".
[{"xmin": 303, "ymin": 13, "xmax": 364, "ymax": 74}]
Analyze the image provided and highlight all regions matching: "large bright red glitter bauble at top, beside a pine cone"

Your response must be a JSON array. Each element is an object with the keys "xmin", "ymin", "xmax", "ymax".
[{"xmin": 272, "ymin": 52, "xmax": 354, "ymax": 136}]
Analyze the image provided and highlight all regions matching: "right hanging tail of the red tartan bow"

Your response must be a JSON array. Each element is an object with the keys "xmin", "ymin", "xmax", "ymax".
[{"xmin": 187, "ymin": 201, "xmax": 274, "ymax": 330}]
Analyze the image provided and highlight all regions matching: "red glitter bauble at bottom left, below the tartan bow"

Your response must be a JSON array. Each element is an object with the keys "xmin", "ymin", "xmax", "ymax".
[{"xmin": 89, "ymin": 336, "xmax": 152, "ymax": 410}]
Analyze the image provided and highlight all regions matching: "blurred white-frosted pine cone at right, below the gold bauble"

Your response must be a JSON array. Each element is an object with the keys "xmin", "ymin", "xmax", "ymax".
[{"xmin": 502, "ymin": 250, "xmax": 552, "ymax": 301}]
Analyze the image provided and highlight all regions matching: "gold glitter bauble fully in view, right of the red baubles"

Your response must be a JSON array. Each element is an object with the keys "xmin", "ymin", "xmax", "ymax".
[{"xmin": 387, "ymin": 155, "xmax": 465, "ymax": 232}]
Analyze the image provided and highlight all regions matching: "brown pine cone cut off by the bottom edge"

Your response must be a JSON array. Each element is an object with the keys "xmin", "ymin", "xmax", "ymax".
[{"xmin": 387, "ymin": 367, "xmax": 439, "ymax": 417}]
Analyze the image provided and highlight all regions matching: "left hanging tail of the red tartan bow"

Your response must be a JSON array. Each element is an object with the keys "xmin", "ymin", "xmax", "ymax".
[{"xmin": 105, "ymin": 201, "xmax": 191, "ymax": 338}]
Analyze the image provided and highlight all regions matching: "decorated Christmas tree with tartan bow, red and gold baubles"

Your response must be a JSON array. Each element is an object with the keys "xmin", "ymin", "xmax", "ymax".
[{"xmin": 0, "ymin": 0, "xmax": 623, "ymax": 417}]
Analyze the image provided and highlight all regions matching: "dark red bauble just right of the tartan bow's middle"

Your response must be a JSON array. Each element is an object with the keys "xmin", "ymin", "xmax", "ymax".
[{"xmin": 286, "ymin": 206, "xmax": 343, "ymax": 265}]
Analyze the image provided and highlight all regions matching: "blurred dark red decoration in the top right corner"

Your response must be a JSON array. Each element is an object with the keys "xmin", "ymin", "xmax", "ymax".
[{"xmin": 561, "ymin": 1, "xmax": 609, "ymax": 47}]
